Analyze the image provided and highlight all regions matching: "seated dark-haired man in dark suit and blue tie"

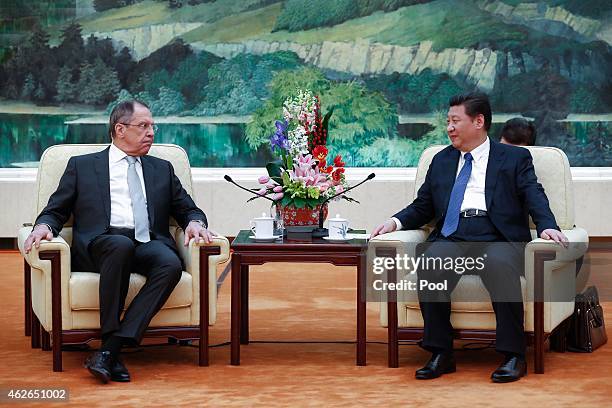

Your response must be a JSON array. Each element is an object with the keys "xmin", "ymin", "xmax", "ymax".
[{"xmin": 372, "ymin": 92, "xmax": 567, "ymax": 382}]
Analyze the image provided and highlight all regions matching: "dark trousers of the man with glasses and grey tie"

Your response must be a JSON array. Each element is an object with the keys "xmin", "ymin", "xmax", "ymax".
[{"xmin": 89, "ymin": 228, "xmax": 183, "ymax": 344}]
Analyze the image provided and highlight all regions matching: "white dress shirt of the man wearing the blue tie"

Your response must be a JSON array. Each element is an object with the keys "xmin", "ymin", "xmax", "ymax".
[{"xmin": 391, "ymin": 137, "xmax": 491, "ymax": 231}]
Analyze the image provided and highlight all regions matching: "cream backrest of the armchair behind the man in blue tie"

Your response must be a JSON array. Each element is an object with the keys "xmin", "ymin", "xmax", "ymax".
[{"xmin": 412, "ymin": 145, "xmax": 574, "ymax": 229}]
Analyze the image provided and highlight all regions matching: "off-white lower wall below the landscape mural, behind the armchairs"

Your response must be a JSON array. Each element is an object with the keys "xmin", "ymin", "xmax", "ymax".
[{"xmin": 0, "ymin": 168, "xmax": 612, "ymax": 237}]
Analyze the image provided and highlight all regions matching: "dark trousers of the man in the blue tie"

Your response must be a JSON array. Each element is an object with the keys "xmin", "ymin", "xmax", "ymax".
[{"xmin": 417, "ymin": 217, "xmax": 526, "ymax": 355}]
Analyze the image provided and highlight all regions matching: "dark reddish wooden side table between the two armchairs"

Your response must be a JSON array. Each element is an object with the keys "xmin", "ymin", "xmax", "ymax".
[{"xmin": 231, "ymin": 230, "xmax": 367, "ymax": 366}]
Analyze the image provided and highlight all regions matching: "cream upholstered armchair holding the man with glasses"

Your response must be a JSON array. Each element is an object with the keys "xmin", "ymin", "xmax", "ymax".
[{"xmin": 18, "ymin": 144, "xmax": 229, "ymax": 371}]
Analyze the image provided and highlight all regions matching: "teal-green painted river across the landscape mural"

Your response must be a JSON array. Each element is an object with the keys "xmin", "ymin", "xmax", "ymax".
[{"xmin": 0, "ymin": 113, "xmax": 612, "ymax": 168}]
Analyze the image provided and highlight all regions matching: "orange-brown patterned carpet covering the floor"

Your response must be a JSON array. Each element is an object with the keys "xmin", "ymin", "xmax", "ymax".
[{"xmin": 0, "ymin": 252, "xmax": 612, "ymax": 407}]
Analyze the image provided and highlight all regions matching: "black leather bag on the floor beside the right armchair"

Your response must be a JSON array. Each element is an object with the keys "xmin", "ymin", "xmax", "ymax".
[{"xmin": 567, "ymin": 286, "xmax": 608, "ymax": 353}]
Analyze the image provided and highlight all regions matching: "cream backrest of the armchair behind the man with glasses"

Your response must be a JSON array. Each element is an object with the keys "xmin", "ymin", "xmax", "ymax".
[{"xmin": 33, "ymin": 144, "xmax": 192, "ymax": 226}]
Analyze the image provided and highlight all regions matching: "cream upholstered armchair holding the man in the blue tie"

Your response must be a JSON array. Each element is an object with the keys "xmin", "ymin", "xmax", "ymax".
[{"xmin": 369, "ymin": 146, "xmax": 588, "ymax": 373}]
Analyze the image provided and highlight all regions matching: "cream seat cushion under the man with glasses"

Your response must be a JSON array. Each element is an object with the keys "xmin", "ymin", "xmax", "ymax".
[{"xmin": 70, "ymin": 272, "xmax": 193, "ymax": 310}]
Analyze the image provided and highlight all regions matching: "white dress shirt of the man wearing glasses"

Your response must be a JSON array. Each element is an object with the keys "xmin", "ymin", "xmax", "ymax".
[{"xmin": 108, "ymin": 144, "xmax": 147, "ymax": 228}]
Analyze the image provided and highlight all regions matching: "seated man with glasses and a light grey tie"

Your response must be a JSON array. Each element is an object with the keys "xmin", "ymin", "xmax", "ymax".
[{"xmin": 25, "ymin": 101, "xmax": 214, "ymax": 383}]
